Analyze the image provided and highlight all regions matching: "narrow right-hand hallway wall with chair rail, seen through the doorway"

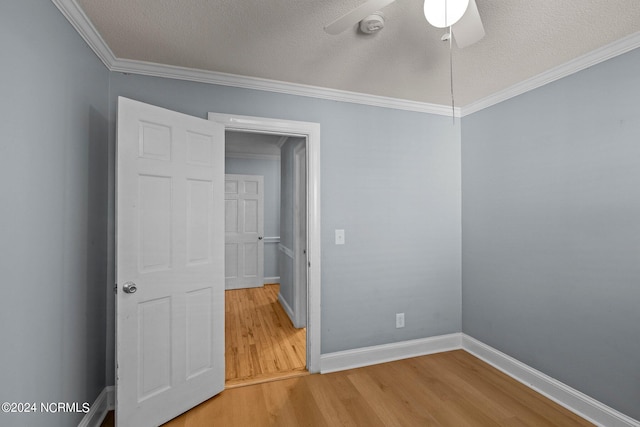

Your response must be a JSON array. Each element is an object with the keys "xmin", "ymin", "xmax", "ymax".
[{"xmin": 278, "ymin": 138, "xmax": 306, "ymax": 316}]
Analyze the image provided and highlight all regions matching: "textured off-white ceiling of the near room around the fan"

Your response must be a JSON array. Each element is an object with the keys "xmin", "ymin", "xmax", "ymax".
[{"xmin": 76, "ymin": 0, "xmax": 640, "ymax": 106}]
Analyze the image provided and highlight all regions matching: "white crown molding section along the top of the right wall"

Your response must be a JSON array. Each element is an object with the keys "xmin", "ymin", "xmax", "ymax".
[{"xmin": 462, "ymin": 32, "xmax": 640, "ymax": 117}]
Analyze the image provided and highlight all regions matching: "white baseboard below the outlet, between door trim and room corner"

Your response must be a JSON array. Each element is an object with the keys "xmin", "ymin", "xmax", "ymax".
[{"xmin": 320, "ymin": 333, "xmax": 462, "ymax": 374}]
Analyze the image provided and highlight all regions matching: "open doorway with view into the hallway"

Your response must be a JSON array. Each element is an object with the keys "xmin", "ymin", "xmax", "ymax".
[{"xmin": 225, "ymin": 131, "xmax": 308, "ymax": 388}]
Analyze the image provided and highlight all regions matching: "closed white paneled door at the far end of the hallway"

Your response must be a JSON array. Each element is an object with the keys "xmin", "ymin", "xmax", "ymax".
[{"xmin": 224, "ymin": 174, "xmax": 264, "ymax": 289}]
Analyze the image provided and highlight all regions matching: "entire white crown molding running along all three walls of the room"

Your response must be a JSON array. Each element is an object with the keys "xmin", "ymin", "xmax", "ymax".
[{"xmin": 51, "ymin": 0, "xmax": 640, "ymax": 117}]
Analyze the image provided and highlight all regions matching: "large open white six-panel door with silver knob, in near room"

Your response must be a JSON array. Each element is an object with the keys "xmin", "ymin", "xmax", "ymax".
[{"xmin": 116, "ymin": 98, "xmax": 224, "ymax": 427}]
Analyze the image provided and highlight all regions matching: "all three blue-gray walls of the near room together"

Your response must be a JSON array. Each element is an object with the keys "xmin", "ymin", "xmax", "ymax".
[{"xmin": 7, "ymin": 0, "xmax": 640, "ymax": 426}]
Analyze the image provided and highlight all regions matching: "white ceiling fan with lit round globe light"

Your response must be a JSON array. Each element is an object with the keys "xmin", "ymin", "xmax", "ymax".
[{"xmin": 324, "ymin": 0, "xmax": 485, "ymax": 48}]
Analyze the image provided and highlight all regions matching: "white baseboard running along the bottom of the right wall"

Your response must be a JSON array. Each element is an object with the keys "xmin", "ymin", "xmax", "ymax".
[{"xmin": 462, "ymin": 334, "xmax": 640, "ymax": 427}]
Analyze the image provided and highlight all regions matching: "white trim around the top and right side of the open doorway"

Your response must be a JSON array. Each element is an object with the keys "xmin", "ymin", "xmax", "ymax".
[{"xmin": 209, "ymin": 113, "xmax": 321, "ymax": 373}]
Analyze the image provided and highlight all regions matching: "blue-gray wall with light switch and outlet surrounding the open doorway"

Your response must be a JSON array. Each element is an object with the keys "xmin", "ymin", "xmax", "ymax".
[{"xmin": 107, "ymin": 73, "xmax": 461, "ymax": 378}]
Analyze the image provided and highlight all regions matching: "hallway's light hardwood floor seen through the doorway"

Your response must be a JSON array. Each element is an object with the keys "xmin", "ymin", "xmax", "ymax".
[{"xmin": 225, "ymin": 284, "xmax": 307, "ymax": 388}]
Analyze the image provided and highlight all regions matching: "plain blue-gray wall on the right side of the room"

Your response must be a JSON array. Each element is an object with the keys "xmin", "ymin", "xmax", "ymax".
[{"xmin": 462, "ymin": 50, "xmax": 640, "ymax": 419}]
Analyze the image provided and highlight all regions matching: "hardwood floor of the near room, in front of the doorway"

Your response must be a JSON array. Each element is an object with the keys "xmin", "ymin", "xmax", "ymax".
[{"xmin": 103, "ymin": 350, "xmax": 592, "ymax": 427}]
